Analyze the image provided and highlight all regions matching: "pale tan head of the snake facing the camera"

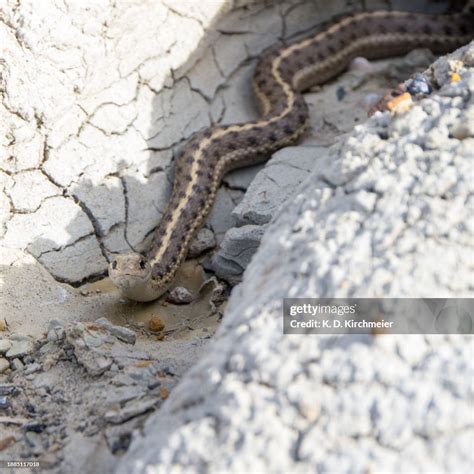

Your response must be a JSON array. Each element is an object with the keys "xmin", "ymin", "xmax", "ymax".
[{"xmin": 109, "ymin": 253, "xmax": 154, "ymax": 301}]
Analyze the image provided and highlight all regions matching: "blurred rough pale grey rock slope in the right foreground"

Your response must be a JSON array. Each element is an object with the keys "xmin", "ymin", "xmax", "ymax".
[{"xmin": 118, "ymin": 43, "xmax": 474, "ymax": 473}]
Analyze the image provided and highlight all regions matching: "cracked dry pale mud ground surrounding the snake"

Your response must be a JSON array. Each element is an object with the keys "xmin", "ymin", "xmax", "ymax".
[{"xmin": 0, "ymin": 0, "xmax": 472, "ymax": 472}]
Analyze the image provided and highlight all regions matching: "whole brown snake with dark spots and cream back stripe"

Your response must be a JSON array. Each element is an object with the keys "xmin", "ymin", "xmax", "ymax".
[{"xmin": 109, "ymin": 7, "xmax": 474, "ymax": 302}]
